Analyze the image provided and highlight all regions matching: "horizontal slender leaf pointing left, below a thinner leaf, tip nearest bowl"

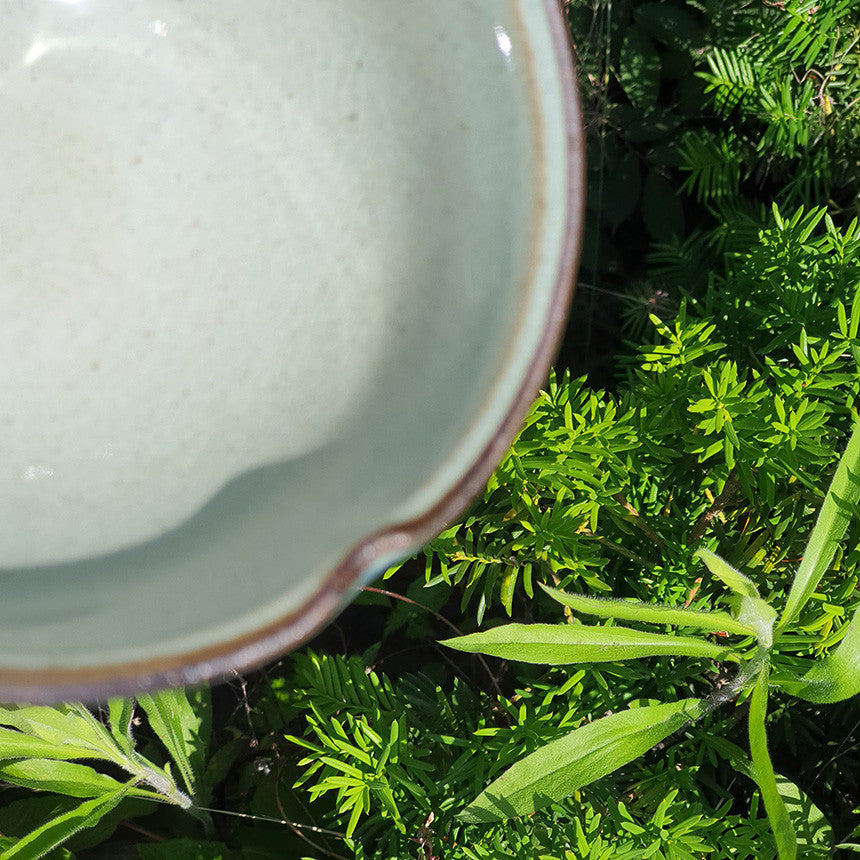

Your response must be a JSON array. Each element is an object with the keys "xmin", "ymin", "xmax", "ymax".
[{"xmin": 442, "ymin": 624, "xmax": 737, "ymax": 665}]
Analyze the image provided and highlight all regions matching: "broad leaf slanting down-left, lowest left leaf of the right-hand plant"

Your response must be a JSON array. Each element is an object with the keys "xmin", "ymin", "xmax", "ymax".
[{"xmin": 459, "ymin": 699, "xmax": 701, "ymax": 823}]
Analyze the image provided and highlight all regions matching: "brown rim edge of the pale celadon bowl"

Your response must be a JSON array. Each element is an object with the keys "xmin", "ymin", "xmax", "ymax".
[{"xmin": 0, "ymin": 0, "xmax": 585, "ymax": 704}]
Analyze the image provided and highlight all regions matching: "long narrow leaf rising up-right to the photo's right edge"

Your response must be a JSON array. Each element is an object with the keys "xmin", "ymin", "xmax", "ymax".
[{"xmin": 777, "ymin": 419, "xmax": 860, "ymax": 630}]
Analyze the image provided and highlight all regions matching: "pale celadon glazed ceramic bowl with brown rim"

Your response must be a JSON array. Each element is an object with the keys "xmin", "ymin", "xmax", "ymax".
[{"xmin": 0, "ymin": 0, "xmax": 584, "ymax": 702}]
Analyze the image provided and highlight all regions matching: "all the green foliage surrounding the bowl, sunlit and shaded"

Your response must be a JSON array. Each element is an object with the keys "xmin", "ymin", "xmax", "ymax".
[{"xmin": 0, "ymin": 0, "xmax": 860, "ymax": 860}]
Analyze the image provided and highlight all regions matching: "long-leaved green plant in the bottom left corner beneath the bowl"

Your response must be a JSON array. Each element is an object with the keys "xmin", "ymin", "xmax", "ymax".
[{"xmin": 0, "ymin": 690, "xmax": 223, "ymax": 860}]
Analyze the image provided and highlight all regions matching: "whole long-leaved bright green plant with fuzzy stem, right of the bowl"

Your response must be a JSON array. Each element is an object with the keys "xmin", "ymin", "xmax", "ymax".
[{"xmin": 444, "ymin": 414, "xmax": 860, "ymax": 858}]
